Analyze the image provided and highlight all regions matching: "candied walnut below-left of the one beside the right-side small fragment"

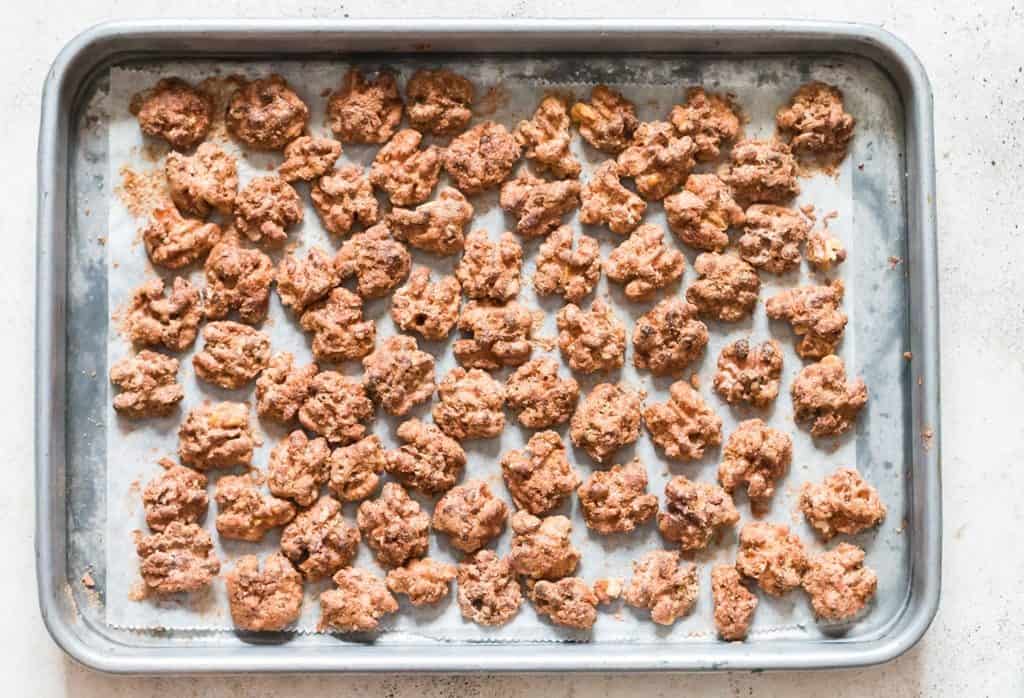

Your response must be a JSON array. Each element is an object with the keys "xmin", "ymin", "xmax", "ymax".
[{"xmin": 686, "ymin": 252, "xmax": 761, "ymax": 322}]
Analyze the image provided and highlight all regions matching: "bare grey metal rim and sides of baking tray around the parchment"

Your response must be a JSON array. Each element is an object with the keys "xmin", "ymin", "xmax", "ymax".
[{"xmin": 36, "ymin": 20, "xmax": 941, "ymax": 672}]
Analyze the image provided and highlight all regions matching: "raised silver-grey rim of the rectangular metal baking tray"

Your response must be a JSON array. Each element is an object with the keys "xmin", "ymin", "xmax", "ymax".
[{"xmin": 35, "ymin": 18, "xmax": 942, "ymax": 673}]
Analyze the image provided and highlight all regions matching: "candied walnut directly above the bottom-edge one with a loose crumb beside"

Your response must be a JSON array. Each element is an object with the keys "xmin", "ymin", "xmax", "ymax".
[{"xmin": 509, "ymin": 511, "xmax": 581, "ymax": 579}]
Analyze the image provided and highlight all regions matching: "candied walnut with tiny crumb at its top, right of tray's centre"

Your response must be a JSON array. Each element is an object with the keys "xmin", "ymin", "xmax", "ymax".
[{"xmin": 643, "ymin": 381, "xmax": 722, "ymax": 461}]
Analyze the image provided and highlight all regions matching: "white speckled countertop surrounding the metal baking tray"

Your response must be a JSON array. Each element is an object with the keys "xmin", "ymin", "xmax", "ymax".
[{"xmin": 0, "ymin": 0, "xmax": 1024, "ymax": 698}]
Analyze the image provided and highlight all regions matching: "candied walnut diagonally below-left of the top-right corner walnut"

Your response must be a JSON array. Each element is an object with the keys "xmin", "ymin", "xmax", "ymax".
[{"xmin": 723, "ymin": 140, "xmax": 800, "ymax": 204}]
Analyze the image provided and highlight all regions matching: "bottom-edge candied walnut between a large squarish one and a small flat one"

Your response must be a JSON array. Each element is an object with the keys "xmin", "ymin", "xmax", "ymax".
[{"xmin": 316, "ymin": 567, "xmax": 398, "ymax": 632}]
